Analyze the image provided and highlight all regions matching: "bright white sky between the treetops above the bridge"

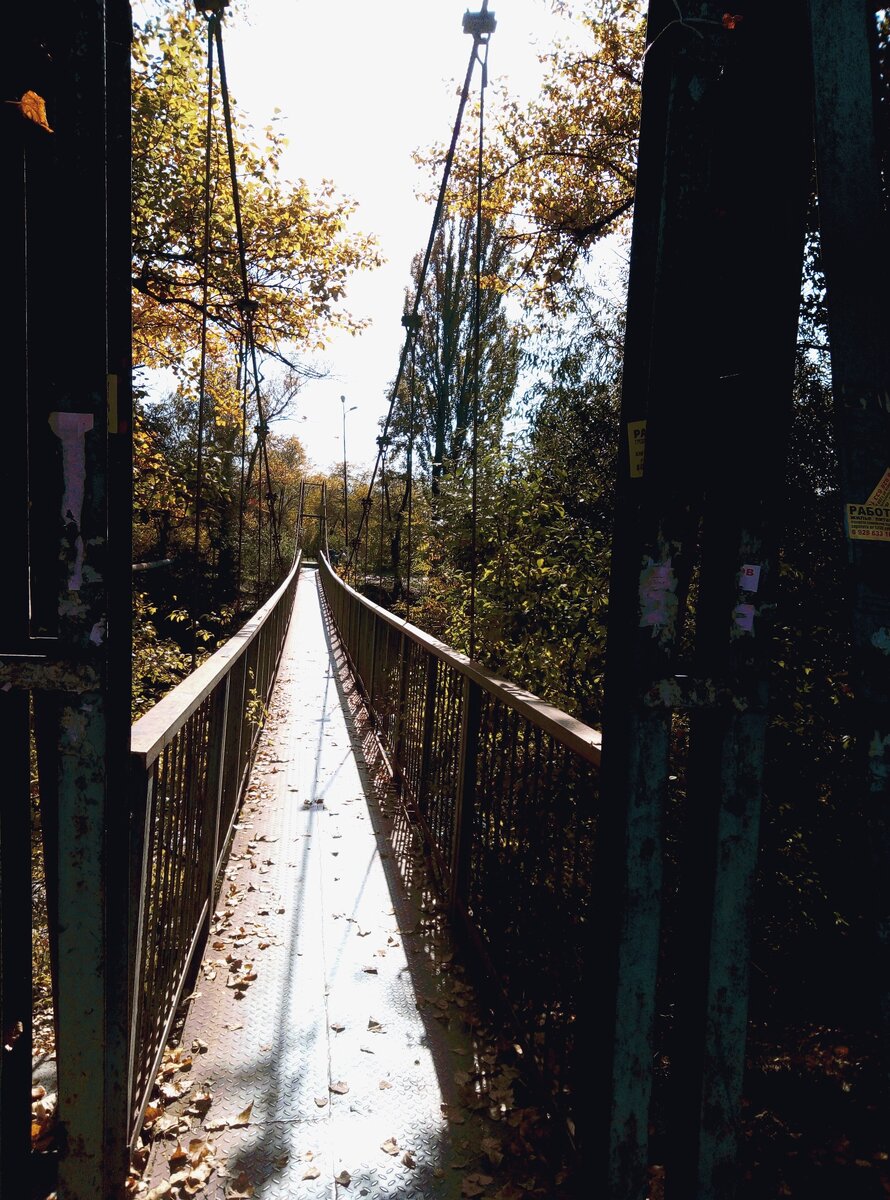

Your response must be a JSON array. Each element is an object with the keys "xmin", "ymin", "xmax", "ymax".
[{"xmin": 223, "ymin": 0, "xmax": 578, "ymax": 469}]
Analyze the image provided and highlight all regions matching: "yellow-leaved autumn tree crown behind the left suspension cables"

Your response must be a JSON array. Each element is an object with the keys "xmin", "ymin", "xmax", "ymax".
[{"xmin": 133, "ymin": 6, "xmax": 380, "ymax": 371}]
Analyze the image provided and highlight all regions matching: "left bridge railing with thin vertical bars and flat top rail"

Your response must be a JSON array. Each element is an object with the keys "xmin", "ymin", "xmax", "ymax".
[{"xmin": 128, "ymin": 556, "xmax": 300, "ymax": 1142}]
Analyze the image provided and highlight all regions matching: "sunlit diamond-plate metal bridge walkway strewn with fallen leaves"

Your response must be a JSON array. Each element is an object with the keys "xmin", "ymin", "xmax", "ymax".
[{"xmin": 145, "ymin": 569, "xmax": 568, "ymax": 1200}]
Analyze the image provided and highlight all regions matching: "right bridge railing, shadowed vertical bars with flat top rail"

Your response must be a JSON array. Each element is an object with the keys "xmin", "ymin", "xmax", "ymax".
[{"xmin": 320, "ymin": 559, "xmax": 600, "ymax": 1142}]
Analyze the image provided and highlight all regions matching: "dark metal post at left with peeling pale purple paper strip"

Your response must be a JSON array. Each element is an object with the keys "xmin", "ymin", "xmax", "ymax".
[{"xmin": 0, "ymin": 0, "xmax": 132, "ymax": 1200}]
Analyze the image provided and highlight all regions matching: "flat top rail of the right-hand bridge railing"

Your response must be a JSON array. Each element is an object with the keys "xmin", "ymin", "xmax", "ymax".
[{"xmin": 319, "ymin": 554, "xmax": 602, "ymax": 766}]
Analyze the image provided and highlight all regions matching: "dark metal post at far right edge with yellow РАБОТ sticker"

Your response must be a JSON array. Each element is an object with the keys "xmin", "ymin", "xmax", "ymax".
[{"xmin": 810, "ymin": 0, "xmax": 890, "ymax": 1070}]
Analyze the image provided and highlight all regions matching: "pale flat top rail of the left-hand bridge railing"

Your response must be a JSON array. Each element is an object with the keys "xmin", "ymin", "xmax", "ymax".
[{"xmin": 130, "ymin": 552, "xmax": 302, "ymax": 768}]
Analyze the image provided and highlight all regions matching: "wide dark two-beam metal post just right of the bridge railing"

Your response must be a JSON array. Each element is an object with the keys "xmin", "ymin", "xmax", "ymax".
[{"xmin": 585, "ymin": 2, "xmax": 810, "ymax": 1200}]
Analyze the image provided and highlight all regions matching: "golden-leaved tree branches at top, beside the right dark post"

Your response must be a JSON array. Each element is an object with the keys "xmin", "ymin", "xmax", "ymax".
[{"xmin": 417, "ymin": 0, "xmax": 647, "ymax": 310}]
